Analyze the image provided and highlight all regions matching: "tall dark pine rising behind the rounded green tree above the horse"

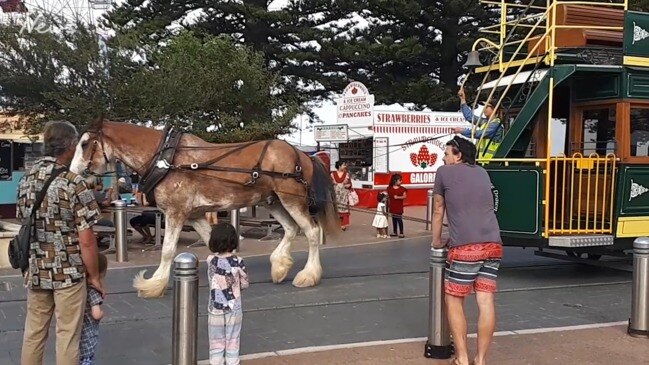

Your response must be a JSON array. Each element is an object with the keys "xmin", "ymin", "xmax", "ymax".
[{"xmin": 105, "ymin": 0, "xmax": 359, "ymax": 119}]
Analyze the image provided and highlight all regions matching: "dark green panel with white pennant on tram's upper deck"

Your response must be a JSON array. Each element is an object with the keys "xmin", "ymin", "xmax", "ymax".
[{"xmin": 624, "ymin": 11, "xmax": 649, "ymax": 66}]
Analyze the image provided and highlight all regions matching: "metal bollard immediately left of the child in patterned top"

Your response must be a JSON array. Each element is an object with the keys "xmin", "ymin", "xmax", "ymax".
[{"xmin": 171, "ymin": 252, "xmax": 198, "ymax": 365}]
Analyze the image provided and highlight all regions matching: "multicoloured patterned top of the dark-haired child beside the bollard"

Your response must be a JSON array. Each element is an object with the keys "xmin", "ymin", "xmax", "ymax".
[{"xmin": 207, "ymin": 255, "xmax": 249, "ymax": 314}]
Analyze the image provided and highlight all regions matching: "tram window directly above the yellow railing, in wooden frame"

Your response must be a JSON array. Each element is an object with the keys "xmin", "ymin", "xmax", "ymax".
[{"xmin": 574, "ymin": 108, "xmax": 615, "ymax": 156}]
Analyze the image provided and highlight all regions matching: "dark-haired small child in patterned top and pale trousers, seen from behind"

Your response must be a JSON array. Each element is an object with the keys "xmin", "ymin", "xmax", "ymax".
[{"xmin": 207, "ymin": 223, "xmax": 249, "ymax": 365}]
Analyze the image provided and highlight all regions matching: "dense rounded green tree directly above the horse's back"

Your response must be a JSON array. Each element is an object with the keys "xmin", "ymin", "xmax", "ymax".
[{"xmin": 116, "ymin": 32, "xmax": 296, "ymax": 142}]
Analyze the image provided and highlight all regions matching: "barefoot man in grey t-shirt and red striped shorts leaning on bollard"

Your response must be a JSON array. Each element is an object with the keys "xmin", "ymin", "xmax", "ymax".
[{"xmin": 432, "ymin": 136, "xmax": 502, "ymax": 365}]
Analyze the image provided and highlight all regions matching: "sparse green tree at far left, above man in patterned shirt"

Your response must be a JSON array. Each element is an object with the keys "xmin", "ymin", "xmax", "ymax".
[{"xmin": 0, "ymin": 19, "xmax": 108, "ymax": 131}]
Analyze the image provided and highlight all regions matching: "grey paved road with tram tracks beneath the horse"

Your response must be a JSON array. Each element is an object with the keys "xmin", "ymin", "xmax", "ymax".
[{"xmin": 0, "ymin": 206, "xmax": 631, "ymax": 365}]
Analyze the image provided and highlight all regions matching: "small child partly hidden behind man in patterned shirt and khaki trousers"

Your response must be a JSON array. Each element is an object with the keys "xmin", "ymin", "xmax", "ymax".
[{"xmin": 79, "ymin": 253, "xmax": 108, "ymax": 365}]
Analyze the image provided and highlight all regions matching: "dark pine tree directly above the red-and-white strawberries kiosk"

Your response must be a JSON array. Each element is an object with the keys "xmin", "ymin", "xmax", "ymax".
[{"xmin": 322, "ymin": 0, "xmax": 497, "ymax": 110}]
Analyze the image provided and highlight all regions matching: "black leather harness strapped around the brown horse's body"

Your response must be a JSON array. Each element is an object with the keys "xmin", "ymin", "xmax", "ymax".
[{"xmin": 131, "ymin": 126, "xmax": 313, "ymax": 205}]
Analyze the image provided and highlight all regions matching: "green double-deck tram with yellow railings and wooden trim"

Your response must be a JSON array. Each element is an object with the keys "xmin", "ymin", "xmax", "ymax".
[{"xmin": 465, "ymin": 0, "xmax": 649, "ymax": 260}]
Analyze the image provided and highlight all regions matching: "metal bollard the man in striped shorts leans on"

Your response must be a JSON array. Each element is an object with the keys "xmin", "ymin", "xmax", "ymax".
[{"xmin": 424, "ymin": 248, "xmax": 453, "ymax": 359}]
